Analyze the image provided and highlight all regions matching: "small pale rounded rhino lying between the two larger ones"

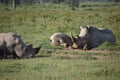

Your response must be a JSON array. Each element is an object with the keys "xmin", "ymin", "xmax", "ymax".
[{"xmin": 50, "ymin": 32, "xmax": 72, "ymax": 47}]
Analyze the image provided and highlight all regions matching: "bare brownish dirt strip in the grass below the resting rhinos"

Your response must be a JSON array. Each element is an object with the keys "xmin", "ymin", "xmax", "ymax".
[{"xmin": 41, "ymin": 48, "xmax": 120, "ymax": 60}]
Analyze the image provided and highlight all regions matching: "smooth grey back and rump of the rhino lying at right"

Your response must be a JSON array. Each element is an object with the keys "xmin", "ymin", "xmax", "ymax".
[{"xmin": 89, "ymin": 28, "xmax": 116, "ymax": 45}]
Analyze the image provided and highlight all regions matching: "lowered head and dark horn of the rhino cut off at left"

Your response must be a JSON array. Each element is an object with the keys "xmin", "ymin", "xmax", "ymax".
[{"xmin": 11, "ymin": 34, "xmax": 42, "ymax": 58}]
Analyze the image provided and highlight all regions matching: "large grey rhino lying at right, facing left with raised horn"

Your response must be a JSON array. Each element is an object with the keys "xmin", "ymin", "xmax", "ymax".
[{"xmin": 71, "ymin": 26, "xmax": 116, "ymax": 50}]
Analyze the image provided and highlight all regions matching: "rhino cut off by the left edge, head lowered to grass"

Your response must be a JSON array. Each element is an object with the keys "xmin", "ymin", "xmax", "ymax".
[{"xmin": 0, "ymin": 32, "xmax": 42, "ymax": 58}]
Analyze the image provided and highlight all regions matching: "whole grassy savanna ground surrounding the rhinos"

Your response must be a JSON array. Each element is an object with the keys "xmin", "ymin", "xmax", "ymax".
[{"xmin": 0, "ymin": 3, "xmax": 120, "ymax": 80}]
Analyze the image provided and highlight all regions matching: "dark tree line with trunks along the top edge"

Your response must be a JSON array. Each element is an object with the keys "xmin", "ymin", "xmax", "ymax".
[{"xmin": 0, "ymin": 0, "xmax": 120, "ymax": 10}]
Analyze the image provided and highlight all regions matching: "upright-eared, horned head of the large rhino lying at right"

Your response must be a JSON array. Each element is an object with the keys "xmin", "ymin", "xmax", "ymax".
[{"xmin": 71, "ymin": 26, "xmax": 94, "ymax": 50}]
